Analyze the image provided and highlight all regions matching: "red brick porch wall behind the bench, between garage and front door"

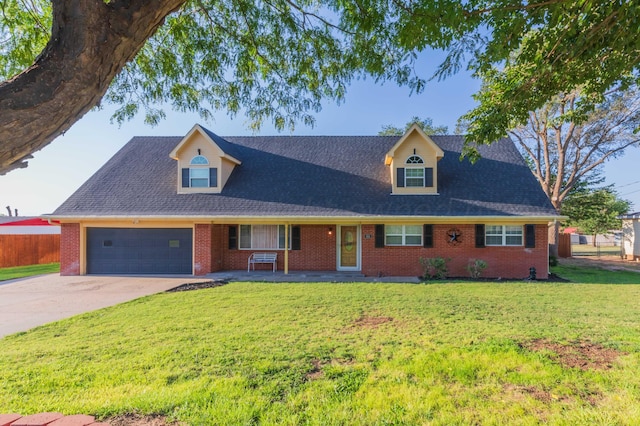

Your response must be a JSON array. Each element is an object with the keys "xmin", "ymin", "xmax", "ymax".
[{"xmin": 212, "ymin": 225, "xmax": 336, "ymax": 271}]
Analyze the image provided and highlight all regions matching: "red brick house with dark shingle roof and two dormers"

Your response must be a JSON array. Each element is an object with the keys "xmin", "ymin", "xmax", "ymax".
[{"xmin": 51, "ymin": 125, "xmax": 559, "ymax": 278}]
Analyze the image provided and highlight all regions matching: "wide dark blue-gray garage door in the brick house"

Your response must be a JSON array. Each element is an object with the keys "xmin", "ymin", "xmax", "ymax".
[{"xmin": 87, "ymin": 228, "xmax": 192, "ymax": 274}]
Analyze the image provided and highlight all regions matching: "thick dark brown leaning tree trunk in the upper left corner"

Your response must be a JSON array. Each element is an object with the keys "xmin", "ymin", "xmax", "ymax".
[{"xmin": 0, "ymin": 0, "xmax": 186, "ymax": 174}]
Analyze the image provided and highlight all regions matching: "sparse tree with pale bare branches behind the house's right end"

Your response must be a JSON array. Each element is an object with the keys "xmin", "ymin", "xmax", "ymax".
[{"xmin": 509, "ymin": 86, "xmax": 640, "ymax": 210}]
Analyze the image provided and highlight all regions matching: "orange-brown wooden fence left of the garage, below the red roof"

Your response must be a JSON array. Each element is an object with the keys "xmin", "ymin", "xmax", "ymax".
[{"xmin": 0, "ymin": 234, "xmax": 60, "ymax": 268}]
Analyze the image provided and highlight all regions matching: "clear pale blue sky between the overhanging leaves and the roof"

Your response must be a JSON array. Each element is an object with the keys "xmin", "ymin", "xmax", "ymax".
[{"xmin": 0, "ymin": 66, "xmax": 640, "ymax": 215}]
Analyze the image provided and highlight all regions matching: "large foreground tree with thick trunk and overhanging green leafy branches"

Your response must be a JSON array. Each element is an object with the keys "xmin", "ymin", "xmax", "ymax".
[{"xmin": 0, "ymin": 0, "xmax": 640, "ymax": 173}]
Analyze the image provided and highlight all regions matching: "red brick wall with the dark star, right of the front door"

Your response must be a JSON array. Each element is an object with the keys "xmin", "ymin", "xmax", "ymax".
[{"xmin": 362, "ymin": 225, "xmax": 549, "ymax": 279}]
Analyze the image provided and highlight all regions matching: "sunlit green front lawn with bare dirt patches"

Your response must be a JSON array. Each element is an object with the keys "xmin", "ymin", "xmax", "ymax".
[{"xmin": 0, "ymin": 273, "xmax": 640, "ymax": 425}]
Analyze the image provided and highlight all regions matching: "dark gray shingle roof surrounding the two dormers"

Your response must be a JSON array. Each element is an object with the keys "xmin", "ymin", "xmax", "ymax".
[{"xmin": 53, "ymin": 132, "xmax": 557, "ymax": 217}]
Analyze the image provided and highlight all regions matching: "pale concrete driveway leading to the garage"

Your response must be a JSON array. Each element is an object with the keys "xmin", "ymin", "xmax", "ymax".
[{"xmin": 0, "ymin": 274, "xmax": 210, "ymax": 338}]
